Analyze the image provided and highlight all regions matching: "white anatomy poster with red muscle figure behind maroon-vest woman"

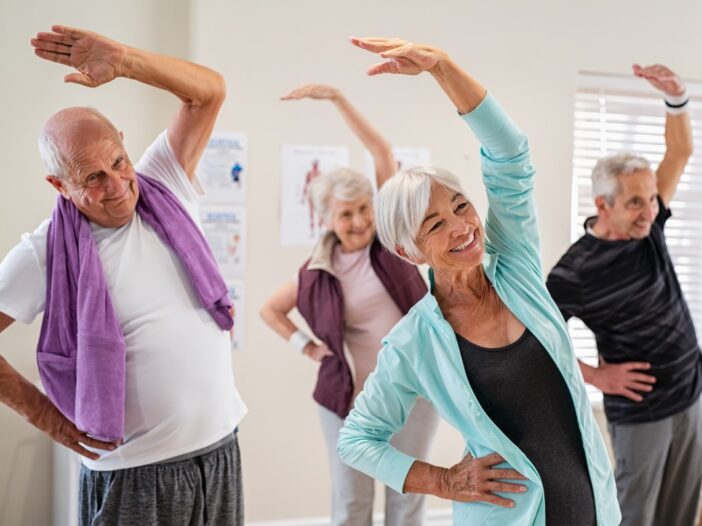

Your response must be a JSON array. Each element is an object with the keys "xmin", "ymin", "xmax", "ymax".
[{"xmin": 280, "ymin": 145, "xmax": 349, "ymax": 246}]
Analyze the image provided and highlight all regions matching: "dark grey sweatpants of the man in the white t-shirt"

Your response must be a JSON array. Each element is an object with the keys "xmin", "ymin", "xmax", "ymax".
[{"xmin": 79, "ymin": 434, "xmax": 244, "ymax": 526}]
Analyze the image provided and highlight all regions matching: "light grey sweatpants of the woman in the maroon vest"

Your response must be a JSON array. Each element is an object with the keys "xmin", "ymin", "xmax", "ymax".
[{"xmin": 319, "ymin": 398, "xmax": 439, "ymax": 526}]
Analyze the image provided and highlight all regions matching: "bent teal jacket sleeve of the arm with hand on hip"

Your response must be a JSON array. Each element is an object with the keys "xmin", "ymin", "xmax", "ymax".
[{"xmin": 337, "ymin": 344, "xmax": 417, "ymax": 493}]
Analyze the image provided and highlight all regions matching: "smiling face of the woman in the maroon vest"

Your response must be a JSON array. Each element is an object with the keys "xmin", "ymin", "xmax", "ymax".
[{"xmin": 328, "ymin": 195, "xmax": 375, "ymax": 252}]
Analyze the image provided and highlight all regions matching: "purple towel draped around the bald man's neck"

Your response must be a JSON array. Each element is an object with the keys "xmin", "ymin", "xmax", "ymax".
[{"xmin": 37, "ymin": 175, "xmax": 234, "ymax": 441}]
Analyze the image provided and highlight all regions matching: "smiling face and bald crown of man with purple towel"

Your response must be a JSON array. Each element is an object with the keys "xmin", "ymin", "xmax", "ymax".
[{"xmin": 47, "ymin": 110, "xmax": 139, "ymax": 228}]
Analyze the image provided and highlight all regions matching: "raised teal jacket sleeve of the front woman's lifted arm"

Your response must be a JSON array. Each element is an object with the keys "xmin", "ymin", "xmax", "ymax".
[{"xmin": 462, "ymin": 93, "xmax": 541, "ymax": 274}]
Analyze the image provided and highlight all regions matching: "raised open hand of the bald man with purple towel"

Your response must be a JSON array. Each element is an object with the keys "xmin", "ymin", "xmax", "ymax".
[{"xmin": 31, "ymin": 26, "xmax": 127, "ymax": 88}]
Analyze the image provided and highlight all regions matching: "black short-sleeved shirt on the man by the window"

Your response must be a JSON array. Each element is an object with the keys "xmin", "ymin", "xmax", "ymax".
[{"xmin": 546, "ymin": 199, "xmax": 702, "ymax": 424}]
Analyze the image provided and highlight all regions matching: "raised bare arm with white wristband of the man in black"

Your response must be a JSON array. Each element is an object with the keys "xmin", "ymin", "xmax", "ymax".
[{"xmin": 633, "ymin": 64, "xmax": 693, "ymax": 206}]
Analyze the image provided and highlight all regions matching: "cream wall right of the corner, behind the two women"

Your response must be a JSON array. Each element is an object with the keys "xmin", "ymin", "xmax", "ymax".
[{"xmin": 192, "ymin": 0, "xmax": 702, "ymax": 520}]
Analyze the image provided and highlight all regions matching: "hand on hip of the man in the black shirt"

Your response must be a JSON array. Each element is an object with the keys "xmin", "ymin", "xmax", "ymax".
[{"xmin": 591, "ymin": 360, "xmax": 656, "ymax": 402}]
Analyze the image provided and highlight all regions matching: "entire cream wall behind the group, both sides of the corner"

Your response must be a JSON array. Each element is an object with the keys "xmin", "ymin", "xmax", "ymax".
[{"xmin": 0, "ymin": 0, "xmax": 702, "ymax": 525}]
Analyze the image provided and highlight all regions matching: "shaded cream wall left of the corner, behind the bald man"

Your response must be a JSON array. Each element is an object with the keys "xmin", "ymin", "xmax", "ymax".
[{"xmin": 0, "ymin": 0, "xmax": 189, "ymax": 526}]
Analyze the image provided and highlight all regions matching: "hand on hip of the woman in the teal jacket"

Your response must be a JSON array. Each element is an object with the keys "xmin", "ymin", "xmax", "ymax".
[{"xmin": 440, "ymin": 453, "xmax": 527, "ymax": 508}]
